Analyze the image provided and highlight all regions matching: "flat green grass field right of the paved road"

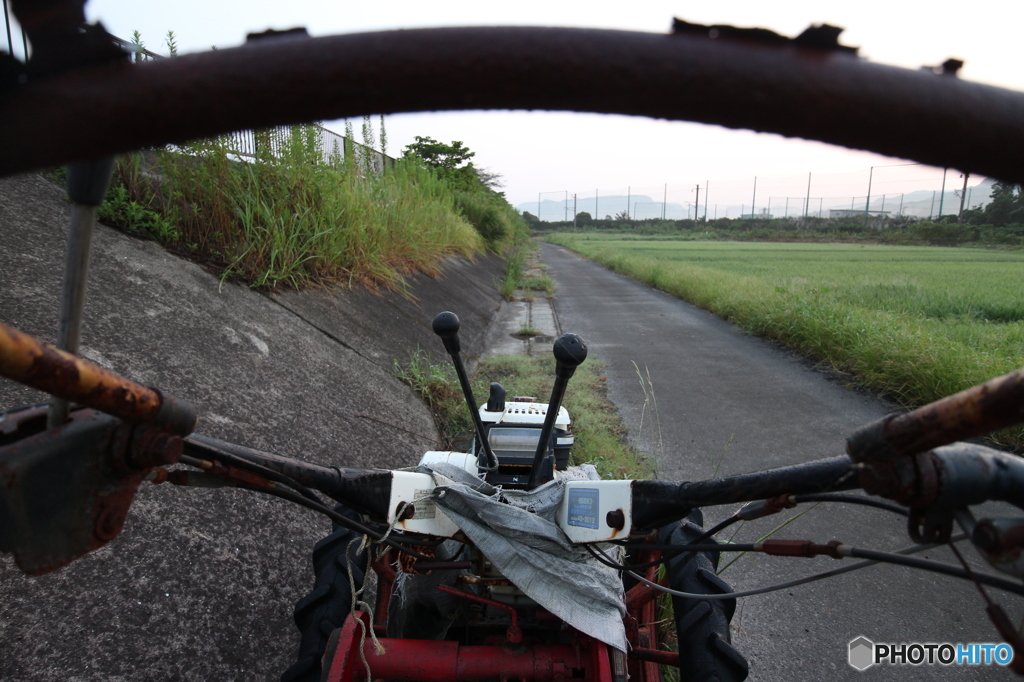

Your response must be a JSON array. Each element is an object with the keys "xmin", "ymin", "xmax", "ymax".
[{"xmin": 546, "ymin": 235, "xmax": 1024, "ymax": 450}]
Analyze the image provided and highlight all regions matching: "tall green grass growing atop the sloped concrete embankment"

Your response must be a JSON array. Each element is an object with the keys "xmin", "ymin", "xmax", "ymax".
[{"xmin": 99, "ymin": 126, "xmax": 485, "ymax": 287}]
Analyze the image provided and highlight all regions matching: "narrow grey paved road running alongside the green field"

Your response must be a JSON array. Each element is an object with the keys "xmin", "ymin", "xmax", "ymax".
[{"xmin": 542, "ymin": 244, "xmax": 1020, "ymax": 680}]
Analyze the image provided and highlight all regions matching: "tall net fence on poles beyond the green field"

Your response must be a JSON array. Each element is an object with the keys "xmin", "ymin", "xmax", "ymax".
[{"xmin": 518, "ymin": 164, "xmax": 992, "ymax": 222}]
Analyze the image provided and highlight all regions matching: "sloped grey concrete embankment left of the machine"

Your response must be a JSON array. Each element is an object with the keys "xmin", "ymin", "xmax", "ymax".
[{"xmin": 0, "ymin": 175, "xmax": 502, "ymax": 680}]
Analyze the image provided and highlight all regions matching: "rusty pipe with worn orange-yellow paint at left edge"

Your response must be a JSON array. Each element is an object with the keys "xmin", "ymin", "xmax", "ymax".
[{"xmin": 0, "ymin": 324, "xmax": 198, "ymax": 435}]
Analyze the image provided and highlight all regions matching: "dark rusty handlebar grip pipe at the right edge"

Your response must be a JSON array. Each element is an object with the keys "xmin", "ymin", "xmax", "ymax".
[{"xmin": 846, "ymin": 370, "xmax": 1024, "ymax": 462}]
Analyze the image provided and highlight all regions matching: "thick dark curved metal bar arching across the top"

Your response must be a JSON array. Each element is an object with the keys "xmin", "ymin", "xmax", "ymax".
[{"xmin": 0, "ymin": 28, "xmax": 1024, "ymax": 182}]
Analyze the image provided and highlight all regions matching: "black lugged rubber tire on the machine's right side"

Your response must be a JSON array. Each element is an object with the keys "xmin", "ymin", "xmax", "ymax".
[{"xmin": 658, "ymin": 509, "xmax": 749, "ymax": 682}]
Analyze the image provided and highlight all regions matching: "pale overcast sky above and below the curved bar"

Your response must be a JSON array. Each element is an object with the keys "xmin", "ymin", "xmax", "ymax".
[{"xmin": 4, "ymin": 0, "xmax": 1024, "ymax": 212}]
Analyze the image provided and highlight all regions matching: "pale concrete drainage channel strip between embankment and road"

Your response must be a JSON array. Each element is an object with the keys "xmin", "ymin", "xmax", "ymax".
[{"xmin": 485, "ymin": 249, "xmax": 561, "ymax": 355}]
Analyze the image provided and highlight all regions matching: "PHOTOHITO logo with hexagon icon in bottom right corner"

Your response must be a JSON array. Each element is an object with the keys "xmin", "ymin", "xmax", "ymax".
[{"xmin": 849, "ymin": 635, "xmax": 1014, "ymax": 671}]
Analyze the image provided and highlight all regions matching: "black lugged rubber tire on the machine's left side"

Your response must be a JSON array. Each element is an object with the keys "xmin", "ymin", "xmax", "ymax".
[{"xmin": 281, "ymin": 505, "xmax": 369, "ymax": 682}]
